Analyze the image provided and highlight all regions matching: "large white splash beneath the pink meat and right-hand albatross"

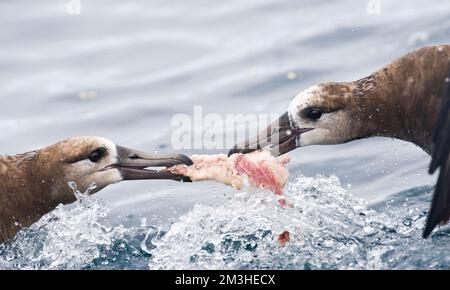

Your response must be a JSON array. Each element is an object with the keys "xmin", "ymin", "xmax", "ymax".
[{"xmin": 149, "ymin": 176, "xmax": 450, "ymax": 269}]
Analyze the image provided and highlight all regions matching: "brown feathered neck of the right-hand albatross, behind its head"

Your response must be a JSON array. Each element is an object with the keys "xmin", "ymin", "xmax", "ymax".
[{"xmin": 354, "ymin": 49, "xmax": 448, "ymax": 153}]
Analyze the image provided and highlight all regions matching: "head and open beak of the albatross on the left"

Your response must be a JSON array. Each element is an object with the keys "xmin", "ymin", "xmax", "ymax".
[{"xmin": 35, "ymin": 137, "xmax": 192, "ymax": 198}]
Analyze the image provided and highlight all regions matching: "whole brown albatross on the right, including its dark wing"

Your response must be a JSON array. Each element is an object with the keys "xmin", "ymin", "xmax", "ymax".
[{"xmin": 230, "ymin": 45, "xmax": 450, "ymax": 237}]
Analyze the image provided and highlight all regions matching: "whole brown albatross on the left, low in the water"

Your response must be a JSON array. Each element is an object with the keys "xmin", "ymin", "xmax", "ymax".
[{"xmin": 0, "ymin": 137, "xmax": 192, "ymax": 242}]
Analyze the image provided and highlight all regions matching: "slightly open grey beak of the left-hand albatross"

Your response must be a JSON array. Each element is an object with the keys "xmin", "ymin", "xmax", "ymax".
[{"xmin": 113, "ymin": 146, "xmax": 193, "ymax": 182}]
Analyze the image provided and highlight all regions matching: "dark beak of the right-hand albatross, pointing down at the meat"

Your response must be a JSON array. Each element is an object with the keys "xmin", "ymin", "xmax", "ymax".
[{"xmin": 228, "ymin": 112, "xmax": 313, "ymax": 156}]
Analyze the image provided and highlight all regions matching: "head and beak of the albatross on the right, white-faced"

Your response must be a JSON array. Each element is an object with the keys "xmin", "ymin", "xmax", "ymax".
[{"xmin": 229, "ymin": 83, "xmax": 362, "ymax": 155}]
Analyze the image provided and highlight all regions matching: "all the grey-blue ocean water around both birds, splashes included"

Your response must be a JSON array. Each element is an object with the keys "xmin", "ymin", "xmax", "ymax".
[{"xmin": 0, "ymin": 0, "xmax": 450, "ymax": 269}]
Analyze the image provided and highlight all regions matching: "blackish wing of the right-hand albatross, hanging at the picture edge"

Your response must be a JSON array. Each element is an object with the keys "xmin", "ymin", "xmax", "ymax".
[{"xmin": 423, "ymin": 68, "xmax": 450, "ymax": 238}]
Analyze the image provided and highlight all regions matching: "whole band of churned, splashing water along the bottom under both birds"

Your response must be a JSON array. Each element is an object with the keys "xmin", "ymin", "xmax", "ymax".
[{"xmin": 0, "ymin": 176, "xmax": 450, "ymax": 269}]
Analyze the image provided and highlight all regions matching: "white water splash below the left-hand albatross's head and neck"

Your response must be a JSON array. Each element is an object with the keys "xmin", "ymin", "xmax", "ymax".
[{"xmin": 0, "ymin": 182, "xmax": 132, "ymax": 269}]
